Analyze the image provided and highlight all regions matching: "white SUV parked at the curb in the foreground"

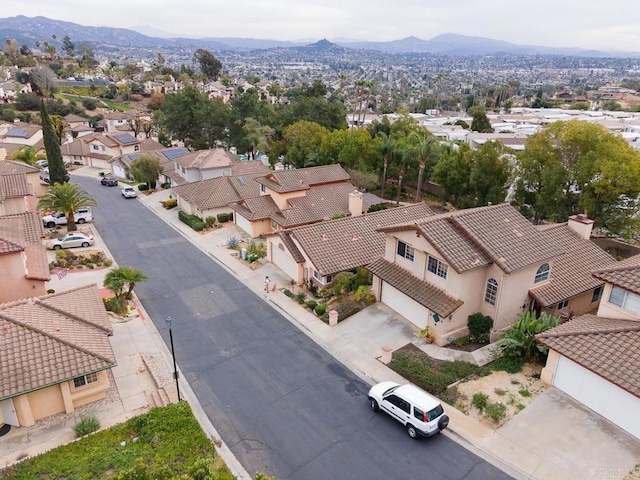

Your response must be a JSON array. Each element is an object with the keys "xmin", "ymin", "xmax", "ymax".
[{"xmin": 369, "ymin": 382, "xmax": 449, "ymax": 438}]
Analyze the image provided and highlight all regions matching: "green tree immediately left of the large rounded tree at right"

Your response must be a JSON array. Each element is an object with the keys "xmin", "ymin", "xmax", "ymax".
[{"xmin": 469, "ymin": 141, "xmax": 513, "ymax": 206}]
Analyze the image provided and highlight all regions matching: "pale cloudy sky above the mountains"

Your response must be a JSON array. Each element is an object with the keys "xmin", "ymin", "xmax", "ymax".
[{"xmin": 5, "ymin": 0, "xmax": 640, "ymax": 51}]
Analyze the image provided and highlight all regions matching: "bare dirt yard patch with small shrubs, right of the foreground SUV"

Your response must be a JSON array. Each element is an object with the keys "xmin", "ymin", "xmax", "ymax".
[{"xmin": 455, "ymin": 365, "xmax": 547, "ymax": 428}]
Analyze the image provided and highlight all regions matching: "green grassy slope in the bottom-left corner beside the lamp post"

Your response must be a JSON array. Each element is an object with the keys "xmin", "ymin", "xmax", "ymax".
[{"xmin": 0, "ymin": 402, "xmax": 234, "ymax": 480}]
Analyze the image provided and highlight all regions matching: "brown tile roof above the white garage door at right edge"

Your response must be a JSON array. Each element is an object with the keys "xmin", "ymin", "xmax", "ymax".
[{"xmin": 536, "ymin": 315, "xmax": 640, "ymax": 397}]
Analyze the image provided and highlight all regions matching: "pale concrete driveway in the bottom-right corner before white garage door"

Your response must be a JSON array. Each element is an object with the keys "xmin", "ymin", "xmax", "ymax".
[{"xmin": 483, "ymin": 387, "xmax": 640, "ymax": 480}]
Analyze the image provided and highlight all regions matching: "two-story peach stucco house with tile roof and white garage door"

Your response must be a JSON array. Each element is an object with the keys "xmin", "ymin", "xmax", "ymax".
[{"xmin": 369, "ymin": 204, "xmax": 610, "ymax": 345}]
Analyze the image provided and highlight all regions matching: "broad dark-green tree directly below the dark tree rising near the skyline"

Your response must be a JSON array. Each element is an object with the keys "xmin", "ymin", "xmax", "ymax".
[{"xmin": 154, "ymin": 86, "xmax": 230, "ymax": 150}]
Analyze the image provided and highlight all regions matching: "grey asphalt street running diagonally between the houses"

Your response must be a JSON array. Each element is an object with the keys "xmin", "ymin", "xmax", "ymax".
[{"xmin": 77, "ymin": 176, "xmax": 510, "ymax": 480}]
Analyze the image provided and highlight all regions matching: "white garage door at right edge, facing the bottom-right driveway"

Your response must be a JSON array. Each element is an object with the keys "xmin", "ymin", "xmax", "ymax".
[{"xmin": 553, "ymin": 356, "xmax": 640, "ymax": 438}]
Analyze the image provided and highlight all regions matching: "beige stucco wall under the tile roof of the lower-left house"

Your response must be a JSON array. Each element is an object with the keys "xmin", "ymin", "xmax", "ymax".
[{"xmin": 13, "ymin": 370, "xmax": 110, "ymax": 427}]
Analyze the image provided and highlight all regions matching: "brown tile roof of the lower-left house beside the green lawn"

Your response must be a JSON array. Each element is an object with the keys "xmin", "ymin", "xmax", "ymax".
[{"xmin": 0, "ymin": 285, "xmax": 116, "ymax": 399}]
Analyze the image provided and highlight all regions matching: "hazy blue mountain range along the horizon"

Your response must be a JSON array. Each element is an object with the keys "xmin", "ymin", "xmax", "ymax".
[{"xmin": 0, "ymin": 15, "xmax": 637, "ymax": 57}]
